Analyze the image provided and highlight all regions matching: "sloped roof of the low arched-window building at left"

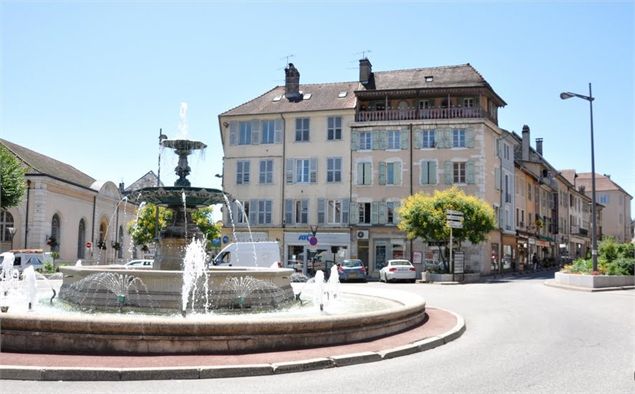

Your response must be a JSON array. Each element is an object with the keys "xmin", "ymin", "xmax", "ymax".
[{"xmin": 0, "ymin": 138, "xmax": 95, "ymax": 189}]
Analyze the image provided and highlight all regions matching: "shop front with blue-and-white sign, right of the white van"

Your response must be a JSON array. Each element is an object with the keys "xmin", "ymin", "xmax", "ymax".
[{"xmin": 284, "ymin": 232, "xmax": 351, "ymax": 276}]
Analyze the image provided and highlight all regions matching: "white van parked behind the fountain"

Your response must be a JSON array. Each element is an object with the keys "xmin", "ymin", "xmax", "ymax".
[{"xmin": 213, "ymin": 241, "xmax": 282, "ymax": 268}]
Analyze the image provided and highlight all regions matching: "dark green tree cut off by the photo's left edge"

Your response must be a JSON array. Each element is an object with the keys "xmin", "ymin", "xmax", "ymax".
[{"xmin": 0, "ymin": 146, "xmax": 26, "ymax": 209}]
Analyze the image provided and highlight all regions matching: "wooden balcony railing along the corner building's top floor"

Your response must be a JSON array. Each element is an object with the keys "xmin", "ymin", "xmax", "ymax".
[{"xmin": 355, "ymin": 107, "xmax": 486, "ymax": 122}]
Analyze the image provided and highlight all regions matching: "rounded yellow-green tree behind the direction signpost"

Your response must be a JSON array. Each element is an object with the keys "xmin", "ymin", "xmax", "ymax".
[{"xmin": 398, "ymin": 187, "xmax": 496, "ymax": 248}]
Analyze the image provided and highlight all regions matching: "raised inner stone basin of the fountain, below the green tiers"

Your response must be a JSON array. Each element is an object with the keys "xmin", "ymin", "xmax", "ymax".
[{"xmin": 59, "ymin": 265, "xmax": 294, "ymax": 312}]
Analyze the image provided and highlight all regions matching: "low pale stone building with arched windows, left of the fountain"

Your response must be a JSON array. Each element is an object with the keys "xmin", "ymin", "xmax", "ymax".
[{"xmin": 0, "ymin": 139, "xmax": 136, "ymax": 264}]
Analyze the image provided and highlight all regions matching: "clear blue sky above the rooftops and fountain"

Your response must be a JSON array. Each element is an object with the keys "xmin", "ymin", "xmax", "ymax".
[{"xmin": 0, "ymin": 0, "xmax": 635, "ymax": 214}]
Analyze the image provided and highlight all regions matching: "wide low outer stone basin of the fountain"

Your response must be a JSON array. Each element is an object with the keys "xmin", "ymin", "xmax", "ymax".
[{"xmin": 2, "ymin": 288, "xmax": 425, "ymax": 354}]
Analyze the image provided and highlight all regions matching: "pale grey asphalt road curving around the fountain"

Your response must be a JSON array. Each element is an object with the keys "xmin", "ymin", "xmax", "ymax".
[{"xmin": 0, "ymin": 276, "xmax": 635, "ymax": 394}]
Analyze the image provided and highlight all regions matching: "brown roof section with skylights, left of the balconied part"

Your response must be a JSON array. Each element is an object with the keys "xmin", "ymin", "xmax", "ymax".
[{"xmin": 220, "ymin": 82, "xmax": 361, "ymax": 116}]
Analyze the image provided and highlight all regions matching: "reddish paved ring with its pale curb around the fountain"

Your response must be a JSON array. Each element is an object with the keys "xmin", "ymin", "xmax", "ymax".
[{"xmin": 0, "ymin": 307, "xmax": 465, "ymax": 381}]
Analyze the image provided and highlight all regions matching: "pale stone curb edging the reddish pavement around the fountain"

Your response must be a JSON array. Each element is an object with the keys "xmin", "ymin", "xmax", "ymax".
[{"xmin": 0, "ymin": 308, "xmax": 466, "ymax": 381}]
